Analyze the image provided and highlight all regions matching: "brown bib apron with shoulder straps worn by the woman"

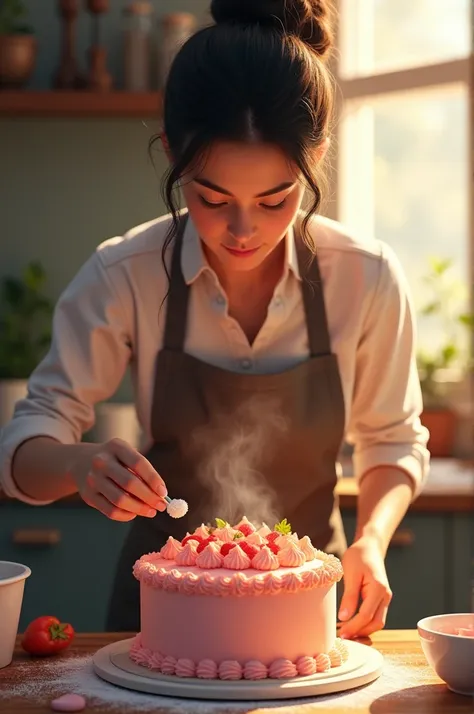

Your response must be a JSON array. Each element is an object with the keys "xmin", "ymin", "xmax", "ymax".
[{"xmin": 106, "ymin": 216, "xmax": 346, "ymax": 632}]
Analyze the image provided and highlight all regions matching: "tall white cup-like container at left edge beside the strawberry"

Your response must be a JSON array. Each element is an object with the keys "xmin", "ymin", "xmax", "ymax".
[{"xmin": 0, "ymin": 560, "xmax": 31, "ymax": 669}]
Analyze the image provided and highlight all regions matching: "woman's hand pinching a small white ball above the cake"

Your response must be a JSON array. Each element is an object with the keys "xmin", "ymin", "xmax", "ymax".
[{"xmin": 70, "ymin": 439, "xmax": 167, "ymax": 521}]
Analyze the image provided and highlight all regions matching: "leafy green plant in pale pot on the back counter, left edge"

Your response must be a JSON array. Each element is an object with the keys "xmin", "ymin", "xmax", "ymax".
[{"xmin": 0, "ymin": 262, "xmax": 53, "ymax": 428}]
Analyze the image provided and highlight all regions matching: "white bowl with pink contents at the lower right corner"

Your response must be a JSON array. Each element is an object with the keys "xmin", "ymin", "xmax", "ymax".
[{"xmin": 417, "ymin": 613, "xmax": 474, "ymax": 696}]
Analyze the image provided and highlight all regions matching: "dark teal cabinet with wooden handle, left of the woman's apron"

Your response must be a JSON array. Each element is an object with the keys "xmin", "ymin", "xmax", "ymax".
[{"xmin": 0, "ymin": 503, "xmax": 130, "ymax": 632}]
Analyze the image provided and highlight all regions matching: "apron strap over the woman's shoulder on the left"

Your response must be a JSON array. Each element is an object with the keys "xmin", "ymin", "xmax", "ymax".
[{"xmin": 163, "ymin": 214, "xmax": 189, "ymax": 352}]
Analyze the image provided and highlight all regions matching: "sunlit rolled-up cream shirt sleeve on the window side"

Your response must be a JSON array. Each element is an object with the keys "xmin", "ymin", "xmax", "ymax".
[{"xmin": 347, "ymin": 244, "xmax": 430, "ymax": 498}]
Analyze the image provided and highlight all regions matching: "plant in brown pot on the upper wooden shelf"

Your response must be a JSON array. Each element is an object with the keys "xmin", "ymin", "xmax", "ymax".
[{"xmin": 0, "ymin": 0, "xmax": 37, "ymax": 89}]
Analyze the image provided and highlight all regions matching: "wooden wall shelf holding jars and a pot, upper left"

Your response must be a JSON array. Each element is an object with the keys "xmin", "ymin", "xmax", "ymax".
[{"xmin": 0, "ymin": 90, "xmax": 162, "ymax": 119}]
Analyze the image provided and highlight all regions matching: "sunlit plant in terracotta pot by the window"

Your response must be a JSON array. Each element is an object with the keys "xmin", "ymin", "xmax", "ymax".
[{"xmin": 417, "ymin": 258, "xmax": 474, "ymax": 457}]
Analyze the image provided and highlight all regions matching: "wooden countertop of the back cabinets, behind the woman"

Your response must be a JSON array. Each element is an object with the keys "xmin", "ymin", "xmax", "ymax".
[{"xmin": 0, "ymin": 459, "xmax": 474, "ymax": 513}]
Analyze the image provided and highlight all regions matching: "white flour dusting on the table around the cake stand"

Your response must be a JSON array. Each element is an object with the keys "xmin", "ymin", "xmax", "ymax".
[{"xmin": 0, "ymin": 655, "xmax": 439, "ymax": 714}]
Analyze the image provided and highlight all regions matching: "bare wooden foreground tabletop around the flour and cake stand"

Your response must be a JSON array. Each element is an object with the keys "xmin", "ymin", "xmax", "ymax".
[{"xmin": 0, "ymin": 630, "xmax": 472, "ymax": 714}]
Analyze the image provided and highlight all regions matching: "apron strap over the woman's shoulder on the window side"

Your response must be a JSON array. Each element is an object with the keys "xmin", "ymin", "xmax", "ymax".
[{"xmin": 294, "ymin": 221, "xmax": 331, "ymax": 357}]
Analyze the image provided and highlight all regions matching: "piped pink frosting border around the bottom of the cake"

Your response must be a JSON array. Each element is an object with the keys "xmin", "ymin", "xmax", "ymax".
[{"xmin": 130, "ymin": 635, "xmax": 348, "ymax": 680}]
